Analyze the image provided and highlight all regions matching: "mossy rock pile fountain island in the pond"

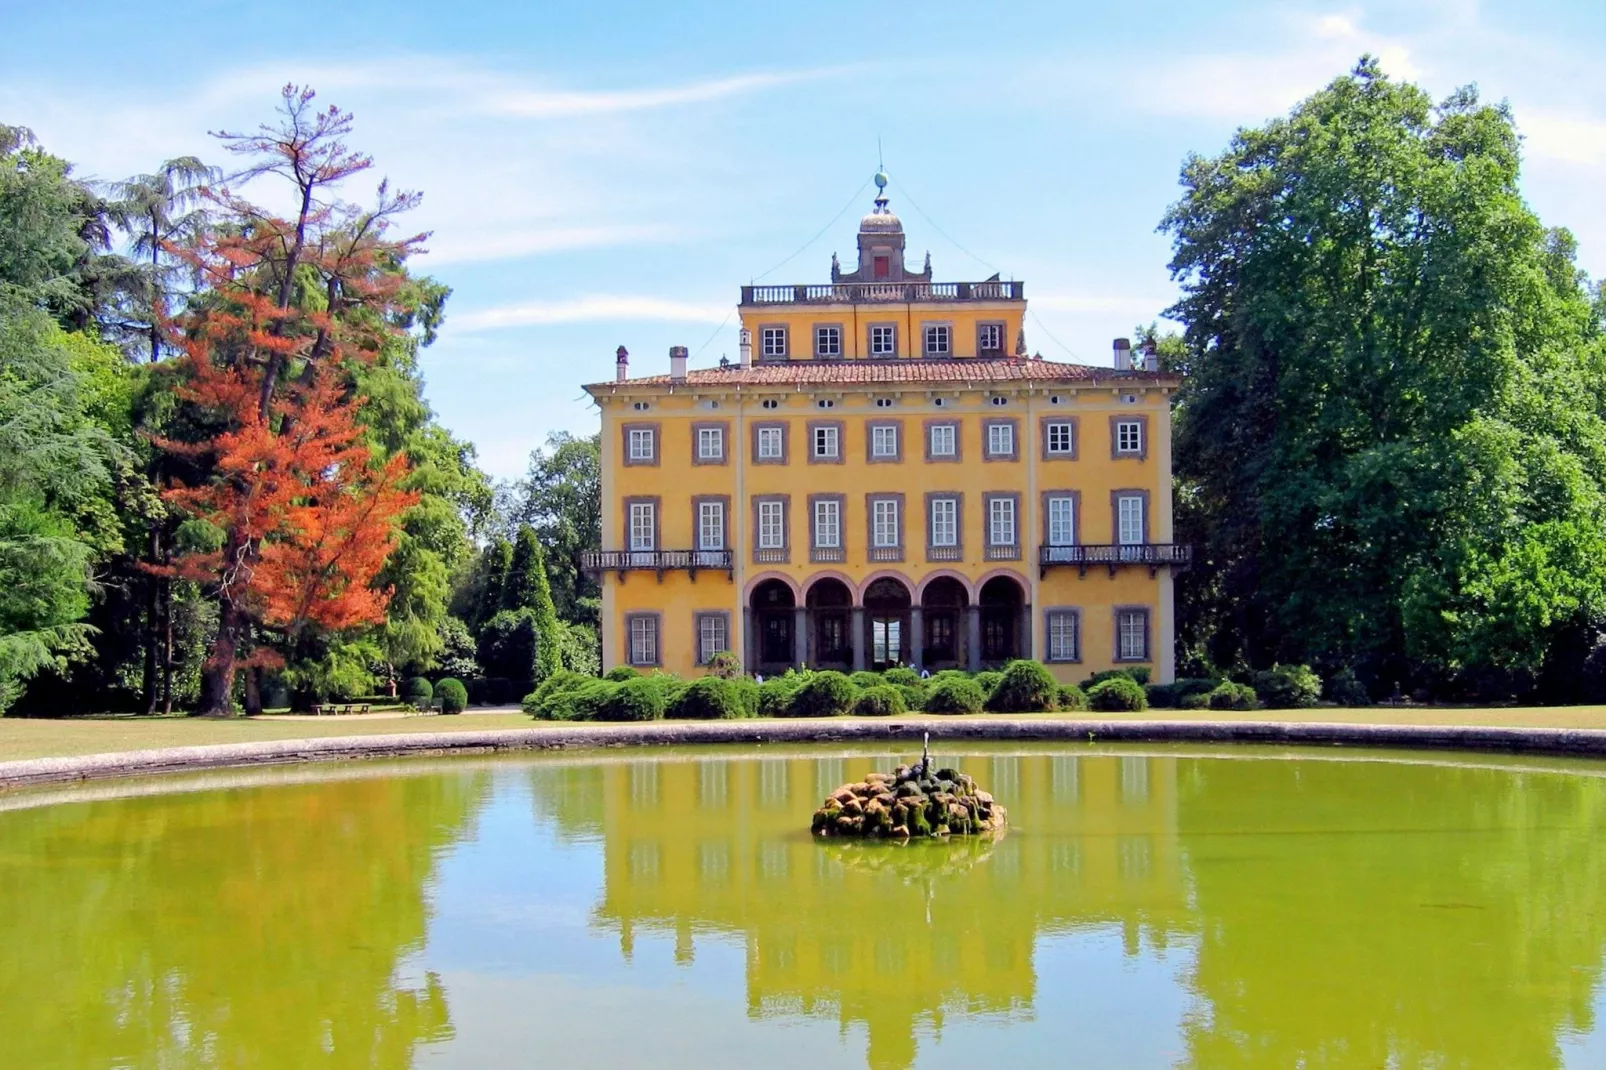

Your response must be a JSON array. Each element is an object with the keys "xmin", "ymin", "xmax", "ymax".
[{"xmin": 809, "ymin": 733, "xmax": 1009, "ymax": 840}]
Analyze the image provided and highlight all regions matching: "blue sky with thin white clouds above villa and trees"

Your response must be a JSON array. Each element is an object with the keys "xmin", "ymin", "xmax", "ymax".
[{"xmin": 0, "ymin": 0, "xmax": 1606, "ymax": 477}]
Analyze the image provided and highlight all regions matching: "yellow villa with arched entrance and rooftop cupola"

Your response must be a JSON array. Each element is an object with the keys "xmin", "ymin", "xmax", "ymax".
[{"xmin": 586, "ymin": 175, "xmax": 1188, "ymax": 683}]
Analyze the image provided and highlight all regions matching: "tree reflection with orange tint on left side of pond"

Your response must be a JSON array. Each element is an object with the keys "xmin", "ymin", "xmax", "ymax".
[{"xmin": 0, "ymin": 773, "xmax": 488, "ymax": 1067}]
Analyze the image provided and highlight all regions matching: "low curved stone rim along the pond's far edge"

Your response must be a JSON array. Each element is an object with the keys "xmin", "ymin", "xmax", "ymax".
[{"xmin": 0, "ymin": 717, "xmax": 1606, "ymax": 789}]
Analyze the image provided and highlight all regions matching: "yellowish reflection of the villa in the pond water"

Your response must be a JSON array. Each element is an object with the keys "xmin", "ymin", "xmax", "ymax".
[{"xmin": 533, "ymin": 755, "xmax": 1188, "ymax": 1067}]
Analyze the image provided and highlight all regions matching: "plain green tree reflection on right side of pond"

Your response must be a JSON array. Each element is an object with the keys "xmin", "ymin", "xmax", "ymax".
[{"xmin": 1180, "ymin": 762, "xmax": 1606, "ymax": 1068}]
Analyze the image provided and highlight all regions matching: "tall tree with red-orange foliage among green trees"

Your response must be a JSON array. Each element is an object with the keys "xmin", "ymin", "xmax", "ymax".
[{"xmin": 161, "ymin": 85, "xmax": 422, "ymax": 713}]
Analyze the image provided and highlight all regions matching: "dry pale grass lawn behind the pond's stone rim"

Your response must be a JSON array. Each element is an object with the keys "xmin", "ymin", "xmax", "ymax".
[{"xmin": 0, "ymin": 705, "xmax": 1606, "ymax": 762}]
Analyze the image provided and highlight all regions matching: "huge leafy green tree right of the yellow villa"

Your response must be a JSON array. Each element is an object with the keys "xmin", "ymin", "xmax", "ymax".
[{"xmin": 1163, "ymin": 58, "xmax": 1606, "ymax": 688}]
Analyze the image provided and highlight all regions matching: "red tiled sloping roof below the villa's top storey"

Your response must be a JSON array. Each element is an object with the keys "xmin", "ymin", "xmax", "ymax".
[{"xmin": 586, "ymin": 357, "xmax": 1176, "ymax": 394}]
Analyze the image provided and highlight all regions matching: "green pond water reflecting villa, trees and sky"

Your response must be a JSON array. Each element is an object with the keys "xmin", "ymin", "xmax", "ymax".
[{"xmin": 0, "ymin": 744, "xmax": 1606, "ymax": 1070}]
